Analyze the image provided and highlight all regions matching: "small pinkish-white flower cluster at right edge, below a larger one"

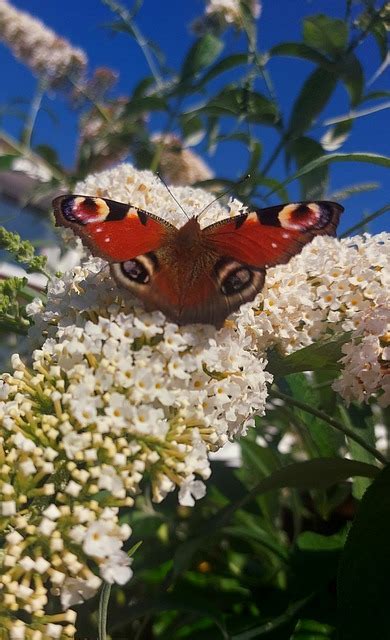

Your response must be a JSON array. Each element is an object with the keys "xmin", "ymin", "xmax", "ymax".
[{"xmin": 333, "ymin": 306, "xmax": 390, "ymax": 407}]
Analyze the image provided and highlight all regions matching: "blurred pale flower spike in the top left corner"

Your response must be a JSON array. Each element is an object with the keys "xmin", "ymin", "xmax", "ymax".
[{"xmin": 0, "ymin": 0, "xmax": 87, "ymax": 87}]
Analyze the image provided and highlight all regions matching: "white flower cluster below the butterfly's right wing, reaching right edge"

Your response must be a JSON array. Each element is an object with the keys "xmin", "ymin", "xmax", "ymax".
[{"xmin": 238, "ymin": 233, "xmax": 390, "ymax": 354}]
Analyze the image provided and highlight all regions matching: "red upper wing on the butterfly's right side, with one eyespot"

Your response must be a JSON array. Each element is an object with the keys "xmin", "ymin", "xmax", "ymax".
[{"xmin": 204, "ymin": 201, "xmax": 344, "ymax": 269}]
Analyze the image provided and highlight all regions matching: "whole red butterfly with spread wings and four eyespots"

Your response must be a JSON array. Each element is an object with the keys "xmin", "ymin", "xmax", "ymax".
[{"xmin": 53, "ymin": 195, "xmax": 344, "ymax": 328}]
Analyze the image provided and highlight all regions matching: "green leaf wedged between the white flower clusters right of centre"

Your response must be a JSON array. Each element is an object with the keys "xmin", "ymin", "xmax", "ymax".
[{"xmin": 268, "ymin": 333, "xmax": 351, "ymax": 377}]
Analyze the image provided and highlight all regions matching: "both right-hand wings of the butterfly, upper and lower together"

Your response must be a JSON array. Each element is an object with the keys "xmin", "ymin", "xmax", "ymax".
[{"xmin": 187, "ymin": 201, "xmax": 343, "ymax": 326}]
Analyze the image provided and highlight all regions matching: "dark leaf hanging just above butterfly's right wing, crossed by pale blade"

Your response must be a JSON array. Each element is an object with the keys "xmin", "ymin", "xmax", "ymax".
[{"xmin": 288, "ymin": 136, "xmax": 329, "ymax": 200}]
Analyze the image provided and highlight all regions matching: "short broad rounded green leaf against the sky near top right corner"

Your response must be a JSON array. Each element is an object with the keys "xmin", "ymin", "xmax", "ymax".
[{"xmin": 303, "ymin": 14, "xmax": 348, "ymax": 57}]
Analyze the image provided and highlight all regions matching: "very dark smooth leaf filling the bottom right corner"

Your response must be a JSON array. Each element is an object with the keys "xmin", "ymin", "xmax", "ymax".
[{"xmin": 338, "ymin": 465, "xmax": 390, "ymax": 640}]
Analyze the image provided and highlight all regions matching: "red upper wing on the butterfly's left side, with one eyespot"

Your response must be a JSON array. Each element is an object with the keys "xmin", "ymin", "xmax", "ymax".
[{"xmin": 53, "ymin": 195, "xmax": 176, "ymax": 262}]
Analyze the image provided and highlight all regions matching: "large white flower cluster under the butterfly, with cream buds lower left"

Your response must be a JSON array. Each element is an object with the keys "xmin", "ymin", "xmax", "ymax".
[{"xmin": 0, "ymin": 168, "xmax": 272, "ymax": 640}]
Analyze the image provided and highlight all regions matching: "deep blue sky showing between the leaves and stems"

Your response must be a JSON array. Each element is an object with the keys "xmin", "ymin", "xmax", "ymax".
[{"xmin": 0, "ymin": 0, "xmax": 389, "ymax": 232}]
